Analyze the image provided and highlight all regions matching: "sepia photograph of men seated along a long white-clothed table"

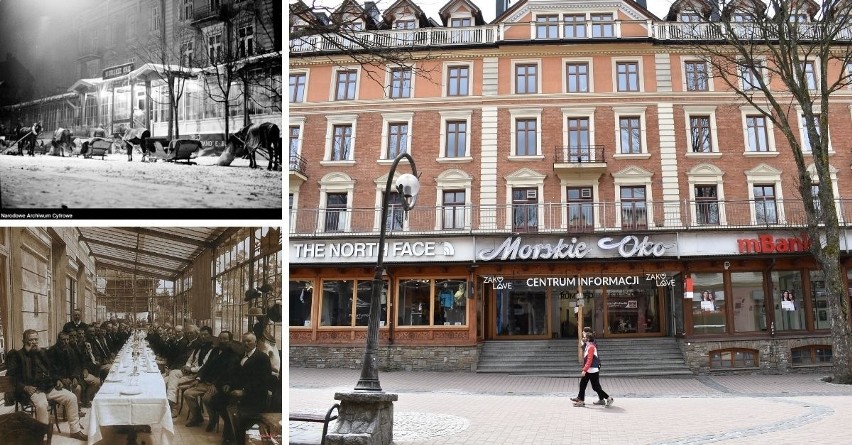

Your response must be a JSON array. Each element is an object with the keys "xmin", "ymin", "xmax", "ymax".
[{"xmin": 0, "ymin": 226, "xmax": 284, "ymax": 445}]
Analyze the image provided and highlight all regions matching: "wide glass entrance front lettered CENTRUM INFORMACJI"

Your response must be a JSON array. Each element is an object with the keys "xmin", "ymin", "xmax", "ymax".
[{"xmin": 480, "ymin": 273, "xmax": 674, "ymax": 339}]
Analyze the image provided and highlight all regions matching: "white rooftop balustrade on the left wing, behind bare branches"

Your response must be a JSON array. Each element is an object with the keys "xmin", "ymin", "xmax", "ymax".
[{"xmin": 290, "ymin": 26, "xmax": 497, "ymax": 54}]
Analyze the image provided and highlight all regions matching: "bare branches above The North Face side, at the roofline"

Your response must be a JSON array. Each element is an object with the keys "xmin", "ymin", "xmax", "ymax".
[{"xmin": 289, "ymin": 0, "xmax": 437, "ymax": 85}]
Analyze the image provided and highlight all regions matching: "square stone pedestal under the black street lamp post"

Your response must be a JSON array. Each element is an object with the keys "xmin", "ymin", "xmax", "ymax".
[{"xmin": 325, "ymin": 391, "xmax": 399, "ymax": 445}]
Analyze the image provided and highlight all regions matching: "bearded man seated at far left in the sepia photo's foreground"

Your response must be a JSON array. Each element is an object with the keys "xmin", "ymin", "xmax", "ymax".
[{"xmin": 8, "ymin": 329, "xmax": 88, "ymax": 441}]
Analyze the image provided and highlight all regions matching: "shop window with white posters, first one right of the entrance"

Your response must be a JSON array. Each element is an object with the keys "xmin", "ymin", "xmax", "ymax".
[{"xmin": 692, "ymin": 273, "xmax": 725, "ymax": 334}]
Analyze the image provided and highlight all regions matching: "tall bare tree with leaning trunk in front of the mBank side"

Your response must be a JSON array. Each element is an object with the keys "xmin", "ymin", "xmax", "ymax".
[{"xmin": 673, "ymin": 0, "xmax": 852, "ymax": 384}]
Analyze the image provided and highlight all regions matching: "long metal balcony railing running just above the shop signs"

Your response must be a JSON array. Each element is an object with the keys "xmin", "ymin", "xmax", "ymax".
[{"xmin": 290, "ymin": 199, "xmax": 852, "ymax": 237}]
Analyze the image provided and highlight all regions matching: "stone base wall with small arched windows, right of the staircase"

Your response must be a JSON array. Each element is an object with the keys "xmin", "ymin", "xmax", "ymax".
[{"xmin": 678, "ymin": 336, "xmax": 831, "ymax": 375}]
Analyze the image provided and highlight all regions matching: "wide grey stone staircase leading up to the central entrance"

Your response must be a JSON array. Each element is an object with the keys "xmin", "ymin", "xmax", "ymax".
[{"xmin": 476, "ymin": 337, "xmax": 693, "ymax": 377}]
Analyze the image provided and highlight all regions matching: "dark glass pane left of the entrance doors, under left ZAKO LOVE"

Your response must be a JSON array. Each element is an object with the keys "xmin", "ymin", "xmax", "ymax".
[{"xmin": 495, "ymin": 280, "xmax": 547, "ymax": 335}]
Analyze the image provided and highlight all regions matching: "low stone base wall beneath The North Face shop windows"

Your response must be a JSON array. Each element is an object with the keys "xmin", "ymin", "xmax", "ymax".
[{"xmin": 290, "ymin": 346, "xmax": 479, "ymax": 372}]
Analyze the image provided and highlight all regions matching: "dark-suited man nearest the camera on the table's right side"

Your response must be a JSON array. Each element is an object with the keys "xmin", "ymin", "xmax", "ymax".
[{"xmin": 222, "ymin": 332, "xmax": 272, "ymax": 445}]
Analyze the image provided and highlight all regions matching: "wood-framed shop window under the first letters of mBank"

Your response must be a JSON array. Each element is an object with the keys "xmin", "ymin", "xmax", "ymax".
[{"xmin": 731, "ymin": 272, "xmax": 766, "ymax": 332}]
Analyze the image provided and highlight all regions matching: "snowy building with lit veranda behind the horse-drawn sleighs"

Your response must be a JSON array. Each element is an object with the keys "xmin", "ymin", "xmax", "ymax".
[{"xmin": 2, "ymin": 0, "xmax": 282, "ymax": 145}]
